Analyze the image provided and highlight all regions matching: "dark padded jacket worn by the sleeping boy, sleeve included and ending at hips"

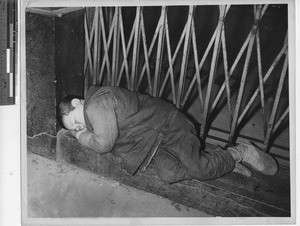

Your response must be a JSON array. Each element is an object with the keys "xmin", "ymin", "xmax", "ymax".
[{"xmin": 79, "ymin": 86, "xmax": 177, "ymax": 174}]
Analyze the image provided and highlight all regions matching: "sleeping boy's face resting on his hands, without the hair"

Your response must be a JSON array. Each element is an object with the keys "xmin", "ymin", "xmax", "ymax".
[{"xmin": 63, "ymin": 98, "xmax": 86, "ymax": 131}]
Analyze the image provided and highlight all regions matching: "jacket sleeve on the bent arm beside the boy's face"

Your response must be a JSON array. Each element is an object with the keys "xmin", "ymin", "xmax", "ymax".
[{"xmin": 79, "ymin": 93, "xmax": 118, "ymax": 153}]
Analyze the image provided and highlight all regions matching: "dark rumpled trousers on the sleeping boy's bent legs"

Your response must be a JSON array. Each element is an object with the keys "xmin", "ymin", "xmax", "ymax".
[{"xmin": 153, "ymin": 112, "xmax": 235, "ymax": 183}]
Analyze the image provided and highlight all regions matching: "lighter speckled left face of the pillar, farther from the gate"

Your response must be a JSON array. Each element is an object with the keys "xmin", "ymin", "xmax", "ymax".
[{"xmin": 26, "ymin": 13, "xmax": 56, "ymax": 136}]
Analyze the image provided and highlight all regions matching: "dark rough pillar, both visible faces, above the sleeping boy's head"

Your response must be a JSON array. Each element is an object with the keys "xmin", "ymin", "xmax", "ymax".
[{"xmin": 26, "ymin": 11, "xmax": 84, "ymax": 136}]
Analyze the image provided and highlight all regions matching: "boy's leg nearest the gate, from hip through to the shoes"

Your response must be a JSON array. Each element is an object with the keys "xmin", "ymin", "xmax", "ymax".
[{"xmin": 161, "ymin": 112, "xmax": 278, "ymax": 180}]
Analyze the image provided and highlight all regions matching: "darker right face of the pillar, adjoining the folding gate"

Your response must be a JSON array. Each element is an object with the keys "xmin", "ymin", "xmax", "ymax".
[{"xmin": 55, "ymin": 10, "xmax": 84, "ymax": 106}]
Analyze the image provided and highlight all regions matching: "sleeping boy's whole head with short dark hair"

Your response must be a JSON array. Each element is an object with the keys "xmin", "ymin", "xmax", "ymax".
[{"xmin": 59, "ymin": 95, "xmax": 86, "ymax": 131}]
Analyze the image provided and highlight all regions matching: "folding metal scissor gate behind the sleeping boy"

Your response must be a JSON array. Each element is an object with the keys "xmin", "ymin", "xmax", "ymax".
[{"xmin": 84, "ymin": 5, "xmax": 289, "ymax": 168}]
